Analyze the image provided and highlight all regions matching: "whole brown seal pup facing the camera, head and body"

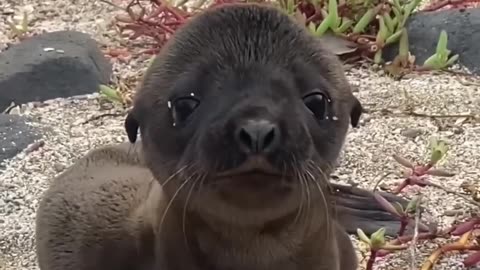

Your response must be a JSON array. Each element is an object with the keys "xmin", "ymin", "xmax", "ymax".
[{"xmin": 37, "ymin": 4, "xmax": 361, "ymax": 270}]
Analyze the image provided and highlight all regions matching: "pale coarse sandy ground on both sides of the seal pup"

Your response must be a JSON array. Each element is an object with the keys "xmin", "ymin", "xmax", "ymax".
[{"xmin": 0, "ymin": 0, "xmax": 480, "ymax": 270}]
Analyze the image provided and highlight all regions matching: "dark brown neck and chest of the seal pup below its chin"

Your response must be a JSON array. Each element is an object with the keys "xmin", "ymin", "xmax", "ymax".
[{"xmin": 148, "ymin": 181, "xmax": 333, "ymax": 270}]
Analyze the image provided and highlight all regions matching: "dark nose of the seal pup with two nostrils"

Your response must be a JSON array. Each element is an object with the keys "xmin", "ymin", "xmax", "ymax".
[{"xmin": 235, "ymin": 120, "xmax": 280, "ymax": 154}]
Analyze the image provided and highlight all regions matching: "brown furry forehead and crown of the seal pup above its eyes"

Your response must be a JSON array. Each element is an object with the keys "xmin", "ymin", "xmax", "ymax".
[{"xmin": 139, "ymin": 4, "xmax": 348, "ymax": 104}]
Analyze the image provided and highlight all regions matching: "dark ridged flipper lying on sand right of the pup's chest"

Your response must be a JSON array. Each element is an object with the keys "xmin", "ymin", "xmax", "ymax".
[{"xmin": 332, "ymin": 183, "xmax": 427, "ymax": 236}]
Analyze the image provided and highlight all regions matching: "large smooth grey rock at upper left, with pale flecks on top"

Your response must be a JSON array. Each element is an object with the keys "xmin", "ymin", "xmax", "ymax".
[{"xmin": 0, "ymin": 31, "xmax": 112, "ymax": 111}]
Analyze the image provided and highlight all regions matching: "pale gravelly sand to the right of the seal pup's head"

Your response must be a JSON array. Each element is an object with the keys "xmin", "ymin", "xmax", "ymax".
[{"xmin": 337, "ymin": 66, "xmax": 480, "ymax": 270}]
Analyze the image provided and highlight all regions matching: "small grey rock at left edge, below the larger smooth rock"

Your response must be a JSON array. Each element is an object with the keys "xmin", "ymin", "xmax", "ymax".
[{"xmin": 0, "ymin": 113, "xmax": 41, "ymax": 167}]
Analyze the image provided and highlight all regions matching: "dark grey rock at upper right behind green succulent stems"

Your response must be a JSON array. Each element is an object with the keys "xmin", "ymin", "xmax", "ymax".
[{"xmin": 384, "ymin": 8, "xmax": 480, "ymax": 74}]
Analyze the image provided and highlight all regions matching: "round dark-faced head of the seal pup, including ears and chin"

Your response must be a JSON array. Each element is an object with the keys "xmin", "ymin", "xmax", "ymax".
[{"xmin": 125, "ymin": 4, "xmax": 361, "ymax": 228}]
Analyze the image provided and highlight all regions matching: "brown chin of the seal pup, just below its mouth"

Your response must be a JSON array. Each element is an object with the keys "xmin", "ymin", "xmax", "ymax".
[{"xmin": 188, "ymin": 157, "xmax": 316, "ymax": 225}]
